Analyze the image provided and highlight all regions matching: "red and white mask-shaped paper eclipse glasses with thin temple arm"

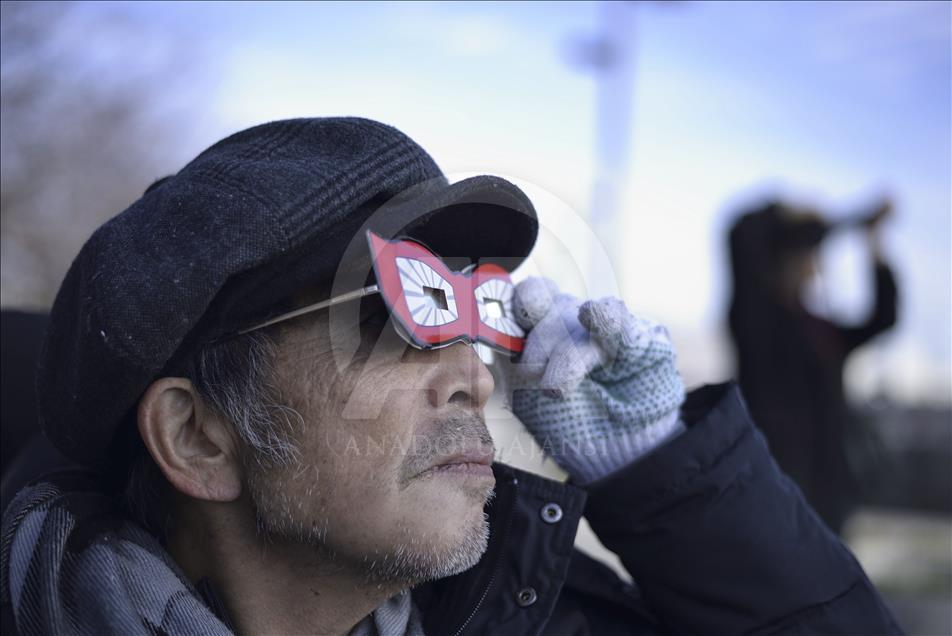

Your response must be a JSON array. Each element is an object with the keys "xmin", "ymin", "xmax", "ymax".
[{"xmin": 234, "ymin": 230, "xmax": 525, "ymax": 353}]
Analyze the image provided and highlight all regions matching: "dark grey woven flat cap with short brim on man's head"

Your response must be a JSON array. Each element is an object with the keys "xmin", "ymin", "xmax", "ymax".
[{"xmin": 37, "ymin": 118, "xmax": 538, "ymax": 466}]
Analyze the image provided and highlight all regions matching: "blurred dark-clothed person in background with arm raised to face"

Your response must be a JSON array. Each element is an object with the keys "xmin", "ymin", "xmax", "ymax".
[{"xmin": 729, "ymin": 200, "xmax": 897, "ymax": 532}]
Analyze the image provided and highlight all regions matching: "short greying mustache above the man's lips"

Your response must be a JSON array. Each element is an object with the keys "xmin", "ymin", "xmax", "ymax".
[{"xmin": 398, "ymin": 413, "xmax": 496, "ymax": 486}]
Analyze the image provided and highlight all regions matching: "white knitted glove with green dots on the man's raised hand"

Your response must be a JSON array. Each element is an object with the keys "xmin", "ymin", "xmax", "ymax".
[{"xmin": 510, "ymin": 278, "xmax": 684, "ymax": 484}]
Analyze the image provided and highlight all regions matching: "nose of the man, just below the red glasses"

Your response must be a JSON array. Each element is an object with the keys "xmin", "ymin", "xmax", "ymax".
[{"xmin": 429, "ymin": 342, "xmax": 495, "ymax": 409}]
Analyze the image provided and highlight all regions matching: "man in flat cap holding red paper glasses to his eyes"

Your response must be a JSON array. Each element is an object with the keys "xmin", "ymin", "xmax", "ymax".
[{"xmin": 2, "ymin": 119, "xmax": 899, "ymax": 635}]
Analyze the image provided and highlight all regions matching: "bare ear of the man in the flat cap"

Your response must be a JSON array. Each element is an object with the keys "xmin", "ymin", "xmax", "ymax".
[{"xmin": 138, "ymin": 378, "xmax": 241, "ymax": 501}]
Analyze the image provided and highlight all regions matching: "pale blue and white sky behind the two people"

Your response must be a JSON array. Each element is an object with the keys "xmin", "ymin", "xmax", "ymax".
[{"xmin": 78, "ymin": 2, "xmax": 952, "ymax": 401}]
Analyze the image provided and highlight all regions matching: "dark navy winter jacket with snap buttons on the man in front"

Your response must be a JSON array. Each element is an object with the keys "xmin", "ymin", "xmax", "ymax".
[{"xmin": 414, "ymin": 384, "xmax": 902, "ymax": 635}]
